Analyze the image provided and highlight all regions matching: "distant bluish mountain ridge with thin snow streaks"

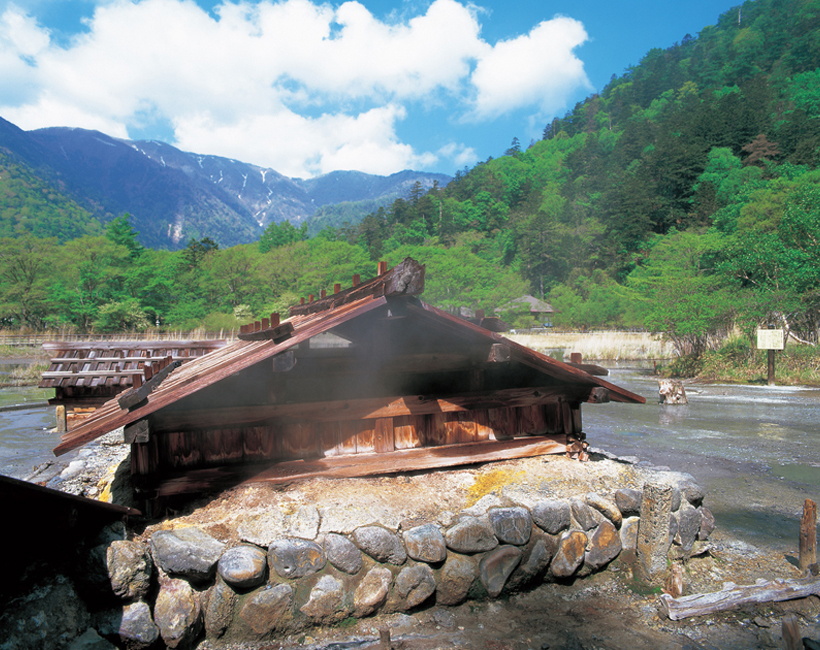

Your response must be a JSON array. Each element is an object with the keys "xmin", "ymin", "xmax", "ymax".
[{"xmin": 0, "ymin": 118, "xmax": 450, "ymax": 249}]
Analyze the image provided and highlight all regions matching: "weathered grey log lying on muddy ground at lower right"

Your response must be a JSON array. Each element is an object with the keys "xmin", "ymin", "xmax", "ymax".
[{"xmin": 660, "ymin": 577, "xmax": 820, "ymax": 621}]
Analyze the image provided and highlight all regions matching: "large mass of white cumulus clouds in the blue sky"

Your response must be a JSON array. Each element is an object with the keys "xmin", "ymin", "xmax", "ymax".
[{"xmin": 0, "ymin": 0, "xmax": 588, "ymax": 176}]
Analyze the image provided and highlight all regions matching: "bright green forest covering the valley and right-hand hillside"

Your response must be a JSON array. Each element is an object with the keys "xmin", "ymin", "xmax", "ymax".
[{"xmin": 0, "ymin": 0, "xmax": 820, "ymax": 368}]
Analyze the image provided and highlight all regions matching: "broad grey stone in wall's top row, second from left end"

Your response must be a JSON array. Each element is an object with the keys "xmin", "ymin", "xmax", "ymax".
[{"xmin": 151, "ymin": 528, "xmax": 225, "ymax": 581}]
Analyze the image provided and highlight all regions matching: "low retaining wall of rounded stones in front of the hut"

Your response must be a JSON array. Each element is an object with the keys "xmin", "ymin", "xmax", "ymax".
[{"xmin": 100, "ymin": 483, "xmax": 714, "ymax": 649}]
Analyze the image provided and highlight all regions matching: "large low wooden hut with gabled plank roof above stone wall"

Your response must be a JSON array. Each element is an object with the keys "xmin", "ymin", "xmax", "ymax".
[{"xmin": 55, "ymin": 258, "xmax": 645, "ymax": 506}]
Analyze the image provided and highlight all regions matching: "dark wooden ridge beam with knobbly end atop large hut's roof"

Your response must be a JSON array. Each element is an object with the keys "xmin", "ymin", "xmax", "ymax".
[{"xmin": 289, "ymin": 257, "xmax": 426, "ymax": 318}]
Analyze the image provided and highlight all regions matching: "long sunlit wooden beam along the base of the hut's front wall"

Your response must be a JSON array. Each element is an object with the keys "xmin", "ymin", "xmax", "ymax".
[{"xmin": 139, "ymin": 434, "xmax": 567, "ymax": 498}]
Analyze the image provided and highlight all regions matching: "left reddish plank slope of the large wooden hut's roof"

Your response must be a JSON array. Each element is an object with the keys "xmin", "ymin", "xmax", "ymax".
[{"xmin": 53, "ymin": 297, "xmax": 387, "ymax": 456}]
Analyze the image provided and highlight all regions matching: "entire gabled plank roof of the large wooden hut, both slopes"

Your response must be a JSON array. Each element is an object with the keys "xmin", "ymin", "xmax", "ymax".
[{"xmin": 54, "ymin": 260, "xmax": 645, "ymax": 456}]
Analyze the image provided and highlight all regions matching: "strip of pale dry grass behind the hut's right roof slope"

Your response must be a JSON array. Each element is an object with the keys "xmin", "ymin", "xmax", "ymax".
[{"xmin": 508, "ymin": 331, "xmax": 674, "ymax": 361}]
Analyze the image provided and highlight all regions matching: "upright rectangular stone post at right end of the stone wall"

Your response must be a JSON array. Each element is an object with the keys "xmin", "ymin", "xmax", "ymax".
[{"xmin": 637, "ymin": 483, "xmax": 672, "ymax": 582}]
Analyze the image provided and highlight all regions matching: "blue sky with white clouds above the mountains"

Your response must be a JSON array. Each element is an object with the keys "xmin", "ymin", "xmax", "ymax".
[{"xmin": 0, "ymin": 0, "xmax": 739, "ymax": 178}]
